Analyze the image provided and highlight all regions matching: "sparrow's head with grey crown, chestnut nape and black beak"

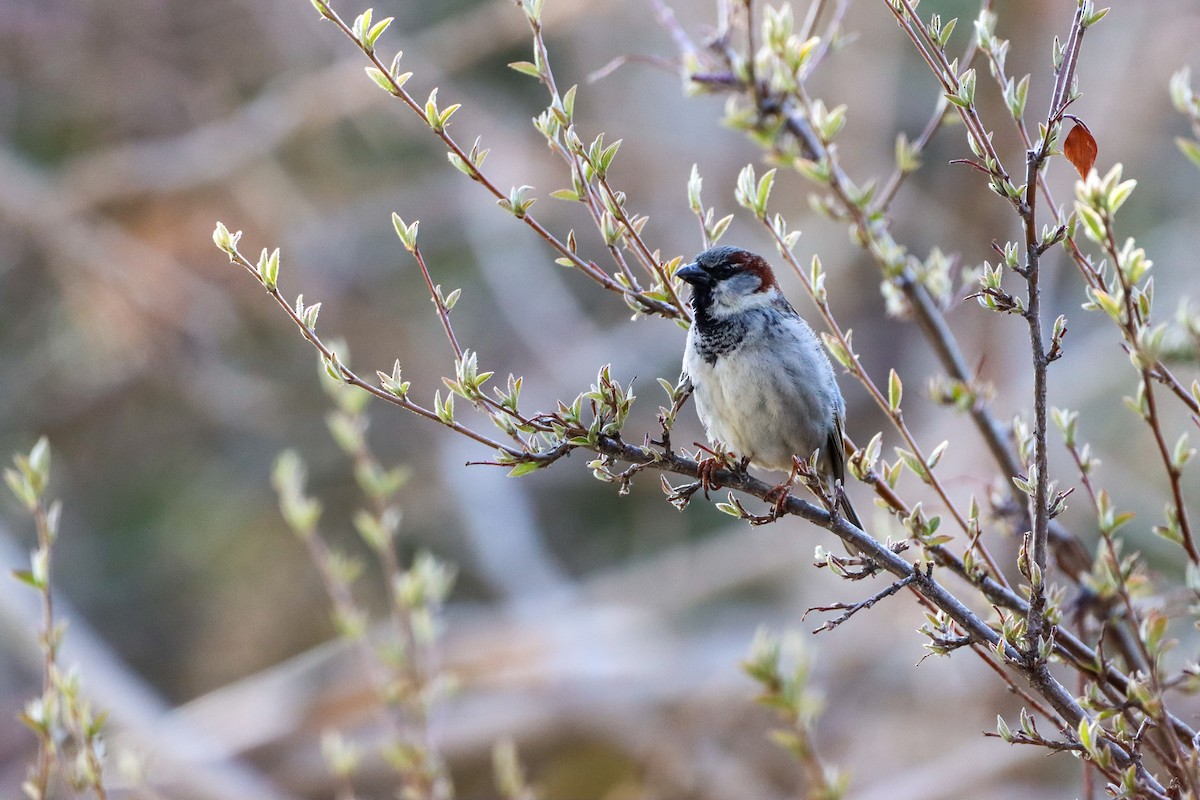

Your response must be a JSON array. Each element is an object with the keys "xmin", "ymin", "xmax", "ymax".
[{"xmin": 676, "ymin": 247, "xmax": 779, "ymax": 319}]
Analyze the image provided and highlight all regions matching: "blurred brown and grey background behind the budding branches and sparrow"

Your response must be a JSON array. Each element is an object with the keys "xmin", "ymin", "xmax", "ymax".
[{"xmin": 0, "ymin": 0, "xmax": 1200, "ymax": 799}]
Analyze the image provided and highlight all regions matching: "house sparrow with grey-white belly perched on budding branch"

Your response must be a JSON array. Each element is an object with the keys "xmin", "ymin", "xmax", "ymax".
[{"xmin": 676, "ymin": 247, "xmax": 863, "ymax": 529}]
